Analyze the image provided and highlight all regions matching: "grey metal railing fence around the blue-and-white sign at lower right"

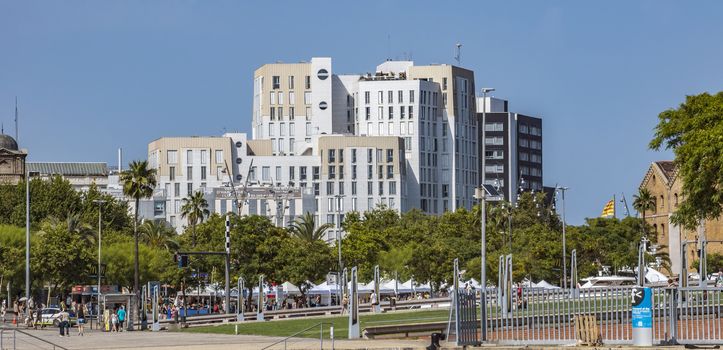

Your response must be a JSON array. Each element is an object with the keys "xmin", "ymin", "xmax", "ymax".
[{"xmin": 486, "ymin": 287, "xmax": 723, "ymax": 345}]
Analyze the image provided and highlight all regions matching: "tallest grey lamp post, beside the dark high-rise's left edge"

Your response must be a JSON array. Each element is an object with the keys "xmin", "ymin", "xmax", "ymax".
[{"xmin": 478, "ymin": 88, "xmax": 495, "ymax": 341}]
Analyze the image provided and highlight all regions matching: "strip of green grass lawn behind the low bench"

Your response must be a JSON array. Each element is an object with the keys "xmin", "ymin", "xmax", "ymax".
[{"xmin": 181, "ymin": 309, "xmax": 449, "ymax": 339}]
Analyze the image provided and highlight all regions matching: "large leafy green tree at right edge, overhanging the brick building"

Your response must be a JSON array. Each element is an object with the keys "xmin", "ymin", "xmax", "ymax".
[{"xmin": 650, "ymin": 91, "xmax": 723, "ymax": 229}]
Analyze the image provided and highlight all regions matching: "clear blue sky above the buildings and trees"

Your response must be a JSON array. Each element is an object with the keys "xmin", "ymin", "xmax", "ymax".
[{"xmin": 0, "ymin": 0, "xmax": 723, "ymax": 224}]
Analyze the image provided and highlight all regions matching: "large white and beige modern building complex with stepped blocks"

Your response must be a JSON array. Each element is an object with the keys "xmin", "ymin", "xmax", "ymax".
[{"xmin": 148, "ymin": 57, "xmax": 548, "ymax": 239}]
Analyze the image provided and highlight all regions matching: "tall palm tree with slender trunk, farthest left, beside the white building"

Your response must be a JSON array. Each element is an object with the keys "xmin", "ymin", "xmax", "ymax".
[{"xmin": 120, "ymin": 160, "xmax": 156, "ymax": 318}]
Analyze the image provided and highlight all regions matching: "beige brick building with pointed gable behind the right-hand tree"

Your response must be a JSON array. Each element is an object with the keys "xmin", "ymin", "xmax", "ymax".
[{"xmin": 640, "ymin": 161, "xmax": 723, "ymax": 274}]
